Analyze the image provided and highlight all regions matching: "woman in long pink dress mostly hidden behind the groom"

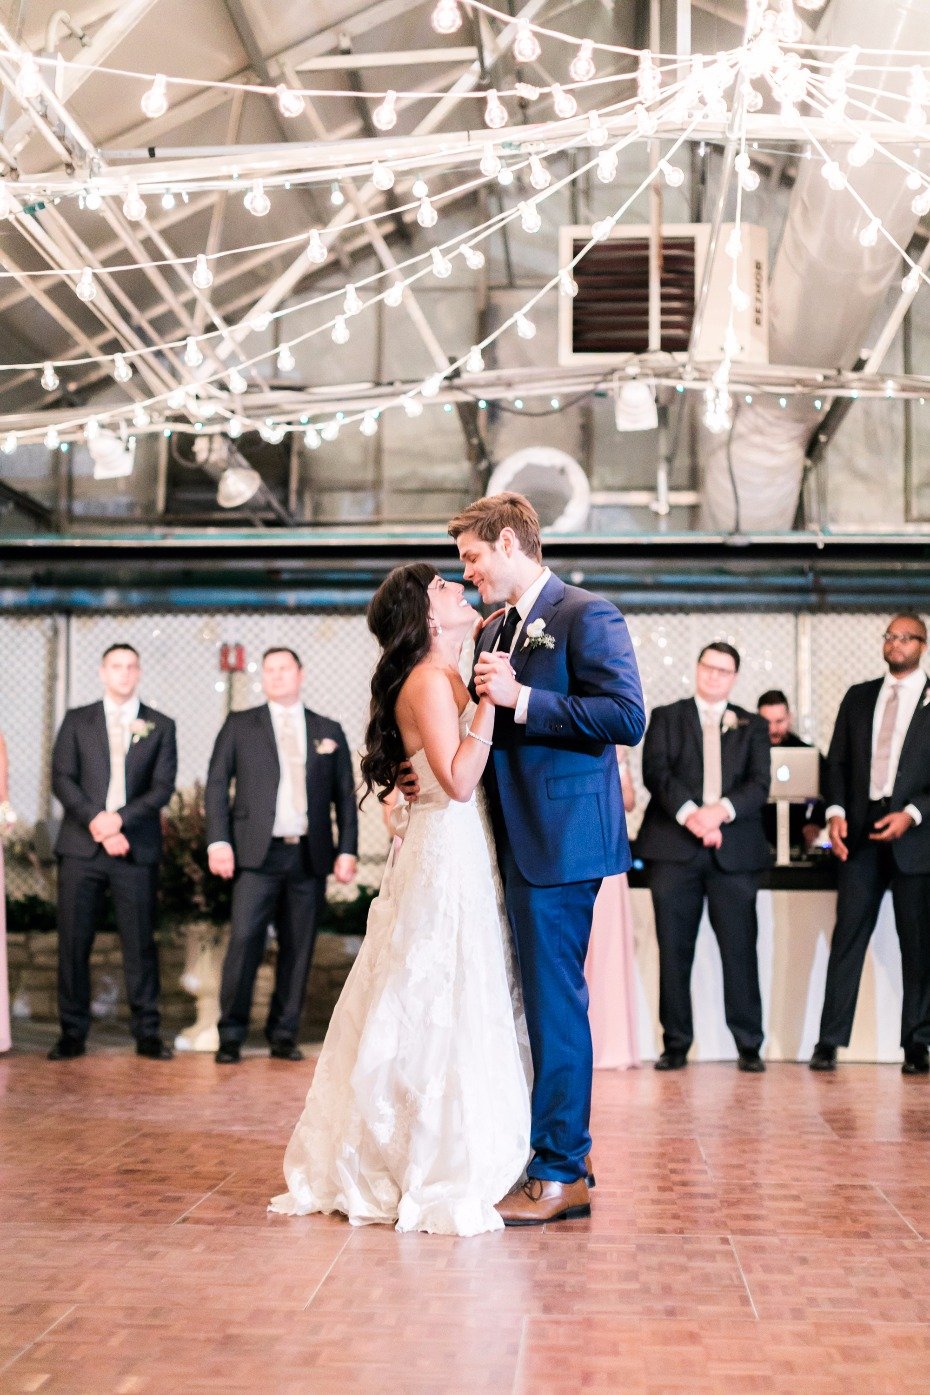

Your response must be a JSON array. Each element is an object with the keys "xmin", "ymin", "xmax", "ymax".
[{"xmin": 584, "ymin": 746, "xmax": 640, "ymax": 1070}]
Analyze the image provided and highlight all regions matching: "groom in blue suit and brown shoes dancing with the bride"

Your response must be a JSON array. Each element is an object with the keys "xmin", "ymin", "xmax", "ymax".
[{"xmin": 449, "ymin": 494, "xmax": 646, "ymax": 1226}]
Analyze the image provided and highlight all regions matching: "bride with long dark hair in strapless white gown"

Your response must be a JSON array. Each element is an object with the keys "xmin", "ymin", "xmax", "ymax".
[{"xmin": 270, "ymin": 562, "xmax": 531, "ymax": 1235}]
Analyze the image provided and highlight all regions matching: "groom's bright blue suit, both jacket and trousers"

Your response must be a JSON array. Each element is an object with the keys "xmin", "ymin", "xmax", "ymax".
[{"xmin": 475, "ymin": 576, "xmax": 646, "ymax": 1182}]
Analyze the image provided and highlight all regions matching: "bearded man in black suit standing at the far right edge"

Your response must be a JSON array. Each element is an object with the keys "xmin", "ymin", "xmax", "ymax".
[{"xmin": 810, "ymin": 615, "xmax": 930, "ymax": 1076}]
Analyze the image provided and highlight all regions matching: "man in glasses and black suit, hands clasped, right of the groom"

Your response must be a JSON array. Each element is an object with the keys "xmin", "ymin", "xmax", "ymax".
[{"xmin": 637, "ymin": 640, "xmax": 770, "ymax": 1073}]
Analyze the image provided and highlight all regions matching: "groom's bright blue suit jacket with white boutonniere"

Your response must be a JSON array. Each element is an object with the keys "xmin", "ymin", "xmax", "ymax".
[{"xmin": 475, "ymin": 576, "xmax": 646, "ymax": 886}]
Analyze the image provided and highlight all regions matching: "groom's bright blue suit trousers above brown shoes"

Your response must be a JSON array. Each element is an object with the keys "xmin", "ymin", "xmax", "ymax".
[{"xmin": 501, "ymin": 848, "xmax": 601, "ymax": 1182}]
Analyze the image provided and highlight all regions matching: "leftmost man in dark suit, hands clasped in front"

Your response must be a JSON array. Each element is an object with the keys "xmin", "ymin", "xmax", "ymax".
[{"xmin": 49, "ymin": 644, "xmax": 177, "ymax": 1060}]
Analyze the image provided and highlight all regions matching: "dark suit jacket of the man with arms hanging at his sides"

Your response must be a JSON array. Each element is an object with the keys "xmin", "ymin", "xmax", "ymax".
[{"xmin": 206, "ymin": 703, "xmax": 358, "ymax": 876}]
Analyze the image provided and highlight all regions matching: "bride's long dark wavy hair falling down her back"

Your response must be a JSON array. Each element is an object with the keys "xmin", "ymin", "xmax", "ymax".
[{"xmin": 361, "ymin": 562, "xmax": 438, "ymax": 804}]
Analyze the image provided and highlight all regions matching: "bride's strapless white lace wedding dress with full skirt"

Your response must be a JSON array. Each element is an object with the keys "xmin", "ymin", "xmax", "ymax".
[{"xmin": 270, "ymin": 704, "xmax": 531, "ymax": 1235}]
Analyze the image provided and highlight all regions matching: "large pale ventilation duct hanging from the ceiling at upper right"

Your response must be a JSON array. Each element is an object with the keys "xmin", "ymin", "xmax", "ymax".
[{"xmin": 700, "ymin": 0, "xmax": 930, "ymax": 533}]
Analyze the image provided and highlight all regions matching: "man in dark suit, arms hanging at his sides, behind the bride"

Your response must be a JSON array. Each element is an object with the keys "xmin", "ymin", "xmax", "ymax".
[{"xmin": 206, "ymin": 649, "xmax": 358, "ymax": 1064}]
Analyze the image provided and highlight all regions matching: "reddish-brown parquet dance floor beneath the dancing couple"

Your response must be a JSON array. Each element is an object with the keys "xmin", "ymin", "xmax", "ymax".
[{"xmin": 0, "ymin": 1048, "xmax": 930, "ymax": 1395}]
